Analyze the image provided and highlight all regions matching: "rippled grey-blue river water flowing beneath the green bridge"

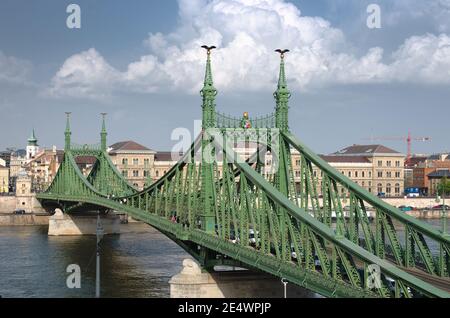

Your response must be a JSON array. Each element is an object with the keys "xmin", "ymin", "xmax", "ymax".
[{"xmin": 0, "ymin": 220, "xmax": 440, "ymax": 298}]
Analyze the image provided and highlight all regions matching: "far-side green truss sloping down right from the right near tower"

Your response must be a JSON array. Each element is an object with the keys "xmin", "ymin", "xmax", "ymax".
[{"xmin": 284, "ymin": 134, "xmax": 450, "ymax": 277}]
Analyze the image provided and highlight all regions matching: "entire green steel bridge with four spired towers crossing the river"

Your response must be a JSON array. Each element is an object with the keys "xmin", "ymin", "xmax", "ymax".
[{"xmin": 37, "ymin": 47, "xmax": 450, "ymax": 298}]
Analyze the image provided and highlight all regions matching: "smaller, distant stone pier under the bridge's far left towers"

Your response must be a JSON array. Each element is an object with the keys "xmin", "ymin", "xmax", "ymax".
[{"xmin": 48, "ymin": 209, "xmax": 121, "ymax": 236}]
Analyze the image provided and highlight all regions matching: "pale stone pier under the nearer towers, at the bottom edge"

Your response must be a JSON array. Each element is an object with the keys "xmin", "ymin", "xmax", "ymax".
[{"xmin": 169, "ymin": 259, "xmax": 320, "ymax": 298}]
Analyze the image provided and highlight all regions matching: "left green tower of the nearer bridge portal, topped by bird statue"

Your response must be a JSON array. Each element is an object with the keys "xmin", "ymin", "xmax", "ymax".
[{"xmin": 200, "ymin": 46, "xmax": 217, "ymax": 233}]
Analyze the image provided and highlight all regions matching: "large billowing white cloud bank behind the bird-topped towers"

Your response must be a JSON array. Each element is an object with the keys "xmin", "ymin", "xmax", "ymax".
[{"xmin": 49, "ymin": 0, "xmax": 450, "ymax": 98}]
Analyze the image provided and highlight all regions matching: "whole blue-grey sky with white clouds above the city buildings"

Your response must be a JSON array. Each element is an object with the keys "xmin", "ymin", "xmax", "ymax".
[{"xmin": 0, "ymin": 0, "xmax": 450, "ymax": 153}]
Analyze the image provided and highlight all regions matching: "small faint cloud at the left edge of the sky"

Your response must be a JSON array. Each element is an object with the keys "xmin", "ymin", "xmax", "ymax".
[{"xmin": 0, "ymin": 51, "xmax": 32, "ymax": 84}]
